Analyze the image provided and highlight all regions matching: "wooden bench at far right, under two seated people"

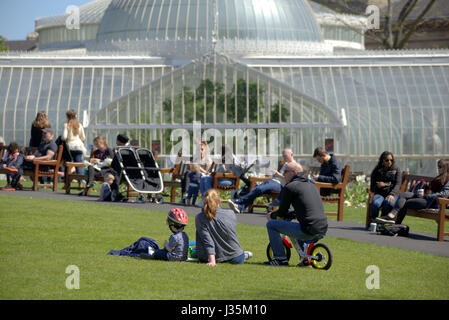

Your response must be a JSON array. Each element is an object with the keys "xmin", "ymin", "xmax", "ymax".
[{"xmin": 365, "ymin": 171, "xmax": 449, "ymax": 241}]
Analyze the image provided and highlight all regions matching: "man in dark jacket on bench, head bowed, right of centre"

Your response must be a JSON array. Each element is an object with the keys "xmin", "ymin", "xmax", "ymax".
[{"xmin": 312, "ymin": 147, "xmax": 342, "ymax": 196}]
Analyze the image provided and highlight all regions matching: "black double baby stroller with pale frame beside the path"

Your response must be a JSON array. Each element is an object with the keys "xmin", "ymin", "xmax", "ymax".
[{"xmin": 115, "ymin": 147, "xmax": 164, "ymax": 203}]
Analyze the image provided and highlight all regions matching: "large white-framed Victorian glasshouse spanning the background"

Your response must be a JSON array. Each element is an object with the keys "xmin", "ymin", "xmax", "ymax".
[{"xmin": 0, "ymin": 0, "xmax": 449, "ymax": 175}]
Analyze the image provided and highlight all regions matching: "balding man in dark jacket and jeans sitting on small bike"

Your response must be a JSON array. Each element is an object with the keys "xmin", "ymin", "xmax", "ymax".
[{"xmin": 265, "ymin": 163, "xmax": 327, "ymax": 266}]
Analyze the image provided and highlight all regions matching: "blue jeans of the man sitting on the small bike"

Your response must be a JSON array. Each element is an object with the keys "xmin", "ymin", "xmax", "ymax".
[{"xmin": 267, "ymin": 220, "xmax": 318, "ymax": 260}]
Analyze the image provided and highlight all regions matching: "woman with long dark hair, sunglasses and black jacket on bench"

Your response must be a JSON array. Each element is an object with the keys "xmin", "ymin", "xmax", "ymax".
[{"xmin": 370, "ymin": 151, "xmax": 402, "ymax": 222}]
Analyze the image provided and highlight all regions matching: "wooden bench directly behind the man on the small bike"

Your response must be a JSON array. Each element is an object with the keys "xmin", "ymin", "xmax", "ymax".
[{"xmin": 248, "ymin": 164, "xmax": 350, "ymax": 221}]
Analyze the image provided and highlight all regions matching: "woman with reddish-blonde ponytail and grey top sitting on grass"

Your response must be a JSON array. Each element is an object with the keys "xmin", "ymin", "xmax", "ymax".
[{"xmin": 195, "ymin": 189, "xmax": 252, "ymax": 266}]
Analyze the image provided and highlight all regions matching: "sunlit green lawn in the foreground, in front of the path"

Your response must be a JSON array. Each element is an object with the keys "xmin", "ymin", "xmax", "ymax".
[{"xmin": 0, "ymin": 195, "xmax": 449, "ymax": 300}]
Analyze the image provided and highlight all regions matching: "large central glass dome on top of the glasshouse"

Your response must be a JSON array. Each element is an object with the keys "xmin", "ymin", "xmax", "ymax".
[{"xmin": 97, "ymin": 0, "xmax": 329, "ymax": 55}]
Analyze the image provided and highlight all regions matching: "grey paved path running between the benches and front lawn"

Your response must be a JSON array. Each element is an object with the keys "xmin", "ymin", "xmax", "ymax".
[{"xmin": 0, "ymin": 191, "xmax": 449, "ymax": 257}]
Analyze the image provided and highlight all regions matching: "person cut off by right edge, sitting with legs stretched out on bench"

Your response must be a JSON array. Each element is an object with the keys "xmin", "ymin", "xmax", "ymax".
[{"xmin": 377, "ymin": 159, "xmax": 449, "ymax": 224}]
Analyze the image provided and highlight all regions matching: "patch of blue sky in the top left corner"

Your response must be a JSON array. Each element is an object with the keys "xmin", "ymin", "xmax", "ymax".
[{"xmin": 0, "ymin": 0, "xmax": 92, "ymax": 40}]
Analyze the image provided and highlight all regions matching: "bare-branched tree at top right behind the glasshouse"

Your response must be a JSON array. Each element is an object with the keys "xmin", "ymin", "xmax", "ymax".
[{"xmin": 315, "ymin": 0, "xmax": 436, "ymax": 49}]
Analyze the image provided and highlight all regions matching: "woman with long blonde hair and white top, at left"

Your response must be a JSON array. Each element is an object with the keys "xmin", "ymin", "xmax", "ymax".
[{"xmin": 62, "ymin": 109, "xmax": 87, "ymax": 174}]
